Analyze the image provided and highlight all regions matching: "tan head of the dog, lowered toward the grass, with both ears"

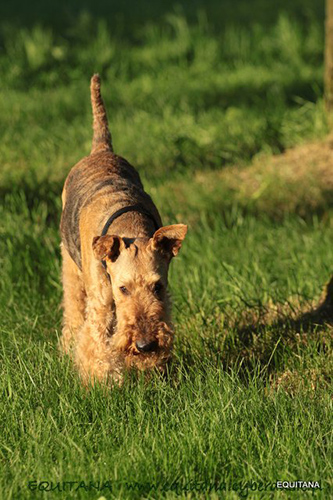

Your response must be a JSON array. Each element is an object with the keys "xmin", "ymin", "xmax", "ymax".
[{"xmin": 93, "ymin": 224, "xmax": 187, "ymax": 370}]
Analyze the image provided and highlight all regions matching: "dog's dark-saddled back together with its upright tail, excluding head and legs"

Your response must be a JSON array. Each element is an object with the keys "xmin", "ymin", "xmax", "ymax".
[{"xmin": 60, "ymin": 75, "xmax": 160, "ymax": 269}]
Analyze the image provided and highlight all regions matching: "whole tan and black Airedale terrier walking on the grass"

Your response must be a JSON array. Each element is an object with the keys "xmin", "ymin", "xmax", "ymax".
[{"xmin": 60, "ymin": 75, "xmax": 187, "ymax": 381}]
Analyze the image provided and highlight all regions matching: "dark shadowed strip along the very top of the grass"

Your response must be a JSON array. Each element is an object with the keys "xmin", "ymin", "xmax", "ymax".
[{"xmin": 0, "ymin": 0, "xmax": 324, "ymax": 40}]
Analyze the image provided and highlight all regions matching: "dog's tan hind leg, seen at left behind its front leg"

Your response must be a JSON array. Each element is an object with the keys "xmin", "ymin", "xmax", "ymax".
[{"xmin": 60, "ymin": 245, "xmax": 86, "ymax": 353}]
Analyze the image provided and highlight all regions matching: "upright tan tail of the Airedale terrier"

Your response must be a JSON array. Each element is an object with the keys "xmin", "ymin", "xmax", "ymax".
[{"xmin": 90, "ymin": 74, "xmax": 113, "ymax": 153}]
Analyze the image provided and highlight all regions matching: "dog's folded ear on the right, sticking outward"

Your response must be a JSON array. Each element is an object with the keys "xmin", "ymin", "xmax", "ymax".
[{"xmin": 151, "ymin": 224, "xmax": 187, "ymax": 259}]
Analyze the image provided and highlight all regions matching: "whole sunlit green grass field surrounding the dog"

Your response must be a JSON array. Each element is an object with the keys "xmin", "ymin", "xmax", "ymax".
[{"xmin": 0, "ymin": 0, "xmax": 333, "ymax": 500}]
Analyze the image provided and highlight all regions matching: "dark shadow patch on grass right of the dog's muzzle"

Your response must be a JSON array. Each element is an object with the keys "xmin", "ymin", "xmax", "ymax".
[{"xmin": 170, "ymin": 277, "xmax": 333, "ymax": 384}]
